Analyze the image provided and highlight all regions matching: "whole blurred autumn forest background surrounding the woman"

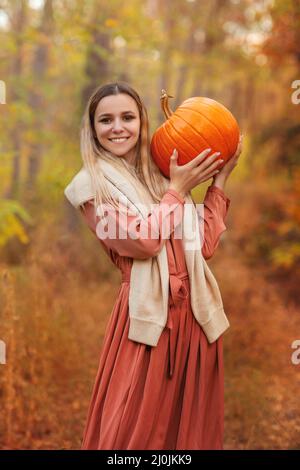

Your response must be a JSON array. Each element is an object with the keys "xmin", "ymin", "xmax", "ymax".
[{"xmin": 0, "ymin": 0, "xmax": 300, "ymax": 449}]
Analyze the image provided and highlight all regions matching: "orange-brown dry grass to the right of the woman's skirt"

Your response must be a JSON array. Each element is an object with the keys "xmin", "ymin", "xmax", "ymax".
[{"xmin": 213, "ymin": 180, "xmax": 300, "ymax": 449}]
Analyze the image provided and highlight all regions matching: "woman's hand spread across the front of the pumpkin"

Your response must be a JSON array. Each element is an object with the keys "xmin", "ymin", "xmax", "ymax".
[{"xmin": 169, "ymin": 149, "xmax": 223, "ymax": 197}]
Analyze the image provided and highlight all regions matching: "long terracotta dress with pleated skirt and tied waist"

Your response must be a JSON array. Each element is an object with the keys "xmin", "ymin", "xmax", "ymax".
[{"xmin": 82, "ymin": 186, "xmax": 230, "ymax": 450}]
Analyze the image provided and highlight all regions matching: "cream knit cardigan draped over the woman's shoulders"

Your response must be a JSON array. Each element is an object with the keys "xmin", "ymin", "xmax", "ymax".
[{"xmin": 64, "ymin": 160, "xmax": 229, "ymax": 346}]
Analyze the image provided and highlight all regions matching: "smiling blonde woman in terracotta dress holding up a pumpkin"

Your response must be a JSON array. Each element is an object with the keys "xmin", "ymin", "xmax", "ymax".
[{"xmin": 65, "ymin": 82, "xmax": 241, "ymax": 450}]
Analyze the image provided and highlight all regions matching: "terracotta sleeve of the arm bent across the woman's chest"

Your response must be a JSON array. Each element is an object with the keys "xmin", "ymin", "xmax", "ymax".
[{"xmin": 80, "ymin": 189, "xmax": 185, "ymax": 259}]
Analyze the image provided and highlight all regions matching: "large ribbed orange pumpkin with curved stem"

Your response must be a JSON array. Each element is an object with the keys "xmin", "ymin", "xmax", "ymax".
[{"xmin": 151, "ymin": 90, "xmax": 240, "ymax": 178}]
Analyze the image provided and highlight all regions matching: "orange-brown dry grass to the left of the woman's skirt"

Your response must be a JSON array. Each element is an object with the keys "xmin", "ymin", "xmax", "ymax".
[{"xmin": 0, "ymin": 223, "xmax": 117, "ymax": 449}]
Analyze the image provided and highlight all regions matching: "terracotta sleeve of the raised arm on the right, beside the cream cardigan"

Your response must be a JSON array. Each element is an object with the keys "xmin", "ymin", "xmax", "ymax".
[{"xmin": 202, "ymin": 186, "xmax": 230, "ymax": 259}]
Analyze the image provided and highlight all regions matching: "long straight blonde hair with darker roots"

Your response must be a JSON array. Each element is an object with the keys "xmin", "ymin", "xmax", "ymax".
[{"xmin": 80, "ymin": 81, "xmax": 169, "ymax": 218}]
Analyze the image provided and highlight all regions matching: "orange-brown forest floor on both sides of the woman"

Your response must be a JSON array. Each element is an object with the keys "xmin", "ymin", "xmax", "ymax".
[{"xmin": 0, "ymin": 182, "xmax": 300, "ymax": 449}]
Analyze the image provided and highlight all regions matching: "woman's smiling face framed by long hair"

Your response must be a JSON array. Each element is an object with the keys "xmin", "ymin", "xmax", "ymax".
[{"xmin": 94, "ymin": 93, "xmax": 140, "ymax": 165}]
